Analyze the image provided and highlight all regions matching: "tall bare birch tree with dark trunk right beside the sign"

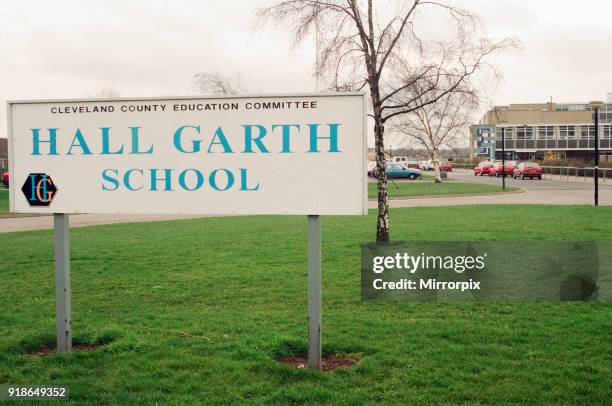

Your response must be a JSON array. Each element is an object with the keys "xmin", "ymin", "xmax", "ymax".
[{"xmin": 258, "ymin": 0, "xmax": 512, "ymax": 243}]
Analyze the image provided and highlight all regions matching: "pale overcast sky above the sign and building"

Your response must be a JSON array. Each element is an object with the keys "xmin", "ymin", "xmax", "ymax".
[{"xmin": 0, "ymin": 0, "xmax": 612, "ymax": 144}]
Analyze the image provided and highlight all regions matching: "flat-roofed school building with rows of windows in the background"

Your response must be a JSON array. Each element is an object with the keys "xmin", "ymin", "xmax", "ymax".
[{"xmin": 470, "ymin": 93, "xmax": 612, "ymax": 161}]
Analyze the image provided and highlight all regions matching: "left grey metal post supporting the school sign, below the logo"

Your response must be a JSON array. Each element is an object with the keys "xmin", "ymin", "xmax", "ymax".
[{"xmin": 53, "ymin": 213, "xmax": 72, "ymax": 352}]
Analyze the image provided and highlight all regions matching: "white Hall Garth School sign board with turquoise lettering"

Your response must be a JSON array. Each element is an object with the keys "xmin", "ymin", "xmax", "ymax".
[{"xmin": 8, "ymin": 93, "xmax": 367, "ymax": 215}]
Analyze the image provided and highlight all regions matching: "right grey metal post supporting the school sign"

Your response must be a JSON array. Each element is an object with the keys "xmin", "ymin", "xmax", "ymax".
[{"xmin": 308, "ymin": 216, "xmax": 321, "ymax": 369}]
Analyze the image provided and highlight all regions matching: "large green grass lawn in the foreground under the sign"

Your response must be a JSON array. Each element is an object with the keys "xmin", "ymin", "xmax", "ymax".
[{"xmin": 0, "ymin": 206, "xmax": 612, "ymax": 405}]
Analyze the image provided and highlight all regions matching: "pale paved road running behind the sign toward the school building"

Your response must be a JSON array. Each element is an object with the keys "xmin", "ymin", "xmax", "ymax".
[{"xmin": 0, "ymin": 170, "xmax": 612, "ymax": 233}]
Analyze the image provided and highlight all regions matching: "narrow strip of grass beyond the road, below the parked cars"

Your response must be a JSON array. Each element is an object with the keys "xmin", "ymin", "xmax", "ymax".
[{"xmin": 368, "ymin": 180, "xmax": 518, "ymax": 199}]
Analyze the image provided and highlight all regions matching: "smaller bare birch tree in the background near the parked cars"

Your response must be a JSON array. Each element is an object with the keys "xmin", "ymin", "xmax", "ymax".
[{"xmin": 393, "ymin": 91, "xmax": 478, "ymax": 183}]
